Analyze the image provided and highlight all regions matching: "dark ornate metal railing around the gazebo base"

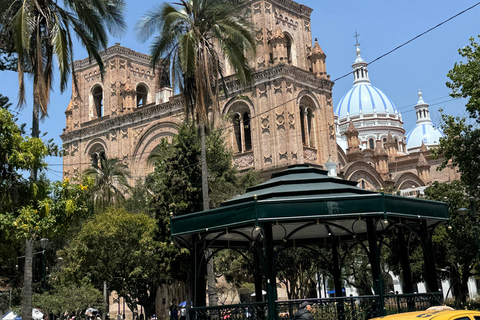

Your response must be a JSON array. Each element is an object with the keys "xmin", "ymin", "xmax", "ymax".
[{"xmin": 190, "ymin": 292, "xmax": 443, "ymax": 320}]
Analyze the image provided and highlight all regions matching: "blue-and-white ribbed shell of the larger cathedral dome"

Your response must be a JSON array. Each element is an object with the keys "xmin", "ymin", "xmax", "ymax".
[{"xmin": 335, "ymin": 83, "xmax": 398, "ymax": 119}]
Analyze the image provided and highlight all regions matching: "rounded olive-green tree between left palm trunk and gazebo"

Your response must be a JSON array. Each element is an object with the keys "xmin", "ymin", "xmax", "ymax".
[{"xmin": 62, "ymin": 208, "xmax": 178, "ymax": 317}]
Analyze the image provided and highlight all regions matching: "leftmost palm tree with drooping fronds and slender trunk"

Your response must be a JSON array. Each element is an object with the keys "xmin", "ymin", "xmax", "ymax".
[{"xmin": 0, "ymin": 0, "xmax": 125, "ymax": 320}]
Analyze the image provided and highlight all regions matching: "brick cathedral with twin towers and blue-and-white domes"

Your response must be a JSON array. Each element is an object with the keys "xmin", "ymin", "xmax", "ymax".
[{"xmin": 61, "ymin": 0, "xmax": 458, "ymax": 195}]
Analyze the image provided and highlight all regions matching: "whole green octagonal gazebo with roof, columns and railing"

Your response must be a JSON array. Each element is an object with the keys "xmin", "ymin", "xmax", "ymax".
[{"xmin": 171, "ymin": 165, "xmax": 449, "ymax": 319}]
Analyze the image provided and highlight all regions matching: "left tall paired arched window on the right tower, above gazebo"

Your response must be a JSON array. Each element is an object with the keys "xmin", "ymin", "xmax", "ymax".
[{"xmin": 223, "ymin": 97, "xmax": 255, "ymax": 153}]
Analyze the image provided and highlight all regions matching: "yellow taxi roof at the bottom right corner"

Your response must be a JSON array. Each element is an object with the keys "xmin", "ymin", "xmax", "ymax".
[{"xmin": 371, "ymin": 306, "xmax": 480, "ymax": 320}]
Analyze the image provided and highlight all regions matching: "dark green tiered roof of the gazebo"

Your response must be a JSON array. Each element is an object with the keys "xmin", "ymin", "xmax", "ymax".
[{"xmin": 171, "ymin": 165, "xmax": 449, "ymax": 242}]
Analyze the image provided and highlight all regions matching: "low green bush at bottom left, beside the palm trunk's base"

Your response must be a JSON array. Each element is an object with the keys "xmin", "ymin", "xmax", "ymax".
[{"xmin": 33, "ymin": 283, "xmax": 104, "ymax": 318}]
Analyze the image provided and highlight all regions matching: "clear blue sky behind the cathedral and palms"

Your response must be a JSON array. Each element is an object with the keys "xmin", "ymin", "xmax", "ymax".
[{"xmin": 0, "ymin": 0, "xmax": 480, "ymax": 180}]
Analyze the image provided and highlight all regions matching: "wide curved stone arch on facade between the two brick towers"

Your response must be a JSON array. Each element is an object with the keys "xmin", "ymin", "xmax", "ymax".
[{"xmin": 131, "ymin": 121, "xmax": 181, "ymax": 176}]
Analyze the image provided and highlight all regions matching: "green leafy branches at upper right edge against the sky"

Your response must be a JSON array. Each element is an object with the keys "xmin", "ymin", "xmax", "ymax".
[{"xmin": 447, "ymin": 37, "xmax": 480, "ymax": 121}]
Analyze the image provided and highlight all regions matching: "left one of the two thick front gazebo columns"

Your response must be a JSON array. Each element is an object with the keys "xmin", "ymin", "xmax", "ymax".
[{"xmin": 263, "ymin": 224, "xmax": 277, "ymax": 320}]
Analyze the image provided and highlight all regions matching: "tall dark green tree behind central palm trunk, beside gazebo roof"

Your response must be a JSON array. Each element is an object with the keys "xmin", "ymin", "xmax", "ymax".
[{"xmin": 147, "ymin": 124, "xmax": 258, "ymax": 304}]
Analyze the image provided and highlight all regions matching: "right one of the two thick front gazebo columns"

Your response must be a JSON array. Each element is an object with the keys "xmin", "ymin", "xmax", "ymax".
[{"xmin": 366, "ymin": 218, "xmax": 385, "ymax": 316}]
